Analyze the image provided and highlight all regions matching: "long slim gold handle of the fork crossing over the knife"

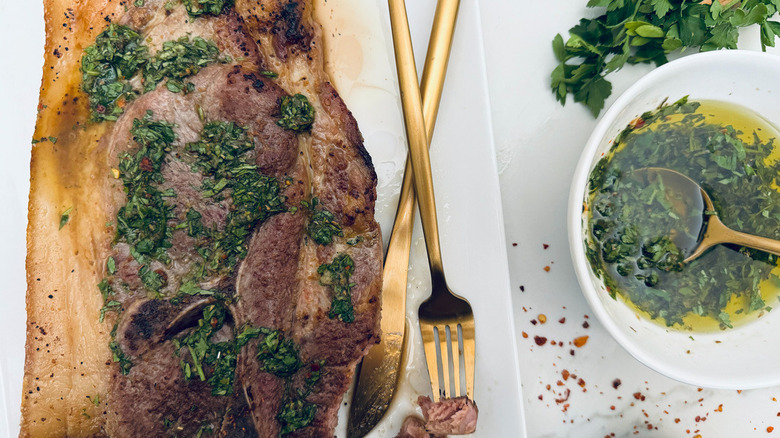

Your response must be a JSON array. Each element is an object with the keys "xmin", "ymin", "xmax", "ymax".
[{"xmin": 388, "ymin": 0, "xmax": 444, "ymax": 286}]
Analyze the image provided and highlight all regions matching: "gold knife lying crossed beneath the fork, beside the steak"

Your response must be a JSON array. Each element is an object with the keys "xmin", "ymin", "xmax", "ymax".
[{"xmin": 347, "ymin": 0, "xmax": 460, "ymax": 438}]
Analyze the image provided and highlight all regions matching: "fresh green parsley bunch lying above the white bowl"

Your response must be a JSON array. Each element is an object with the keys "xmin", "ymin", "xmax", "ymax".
[{"xmin": 550, "ymin": 0, "xmax": 780, "ymax": 116}]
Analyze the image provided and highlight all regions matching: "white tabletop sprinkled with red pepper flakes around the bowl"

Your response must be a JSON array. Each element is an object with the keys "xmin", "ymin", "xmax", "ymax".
[{"xmin": 481, "ymin": 0, "xmax": 780, "ymax": 438}]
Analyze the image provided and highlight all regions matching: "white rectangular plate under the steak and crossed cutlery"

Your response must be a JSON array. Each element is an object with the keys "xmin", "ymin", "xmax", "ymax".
[{"xmin": 0, "ymin": 0, "xmax": 525, "ymax": 438}]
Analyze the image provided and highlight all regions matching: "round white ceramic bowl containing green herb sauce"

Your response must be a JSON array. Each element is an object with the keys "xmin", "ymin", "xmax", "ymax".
[{"xmin": 568, "ymin": 51, "xmax": 780, "ymax": 389}]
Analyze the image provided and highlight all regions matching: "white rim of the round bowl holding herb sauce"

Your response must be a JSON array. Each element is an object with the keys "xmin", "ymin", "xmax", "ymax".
[{"xmin": 567, "ymin": 50, "xmax": 780, "ymax": 389}]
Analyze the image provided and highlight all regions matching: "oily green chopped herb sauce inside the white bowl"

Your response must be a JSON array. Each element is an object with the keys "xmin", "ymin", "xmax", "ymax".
[{"xmin": 585, "ymin": 98, "xmax": 780, "ymax": 331}]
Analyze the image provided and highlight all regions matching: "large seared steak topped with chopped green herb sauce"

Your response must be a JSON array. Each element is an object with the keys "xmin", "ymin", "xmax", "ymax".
[{"xmin": 22, "ymin": 0, "xmax": 382, "ymax": 437}]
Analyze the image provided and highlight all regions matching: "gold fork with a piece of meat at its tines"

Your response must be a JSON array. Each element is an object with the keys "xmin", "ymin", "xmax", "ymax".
[{"xmin": 388, "ymin": 0, "xmax": 475, "ymax": 401}]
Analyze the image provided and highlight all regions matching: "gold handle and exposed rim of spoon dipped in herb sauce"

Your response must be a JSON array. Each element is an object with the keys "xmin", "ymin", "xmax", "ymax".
[{"xmin": 635, "ymin": 167, "xmax": 780, "ymax": 263}]
